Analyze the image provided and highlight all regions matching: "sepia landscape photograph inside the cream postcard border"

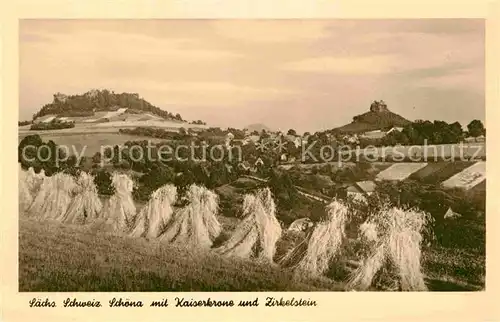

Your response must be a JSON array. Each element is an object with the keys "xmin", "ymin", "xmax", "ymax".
[{"xmin": 17, "ymin": 18, "xmax": 486, "ymax": 296}]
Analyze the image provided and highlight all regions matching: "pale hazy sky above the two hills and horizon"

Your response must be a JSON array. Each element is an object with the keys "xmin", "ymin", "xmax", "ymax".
[{"xmin": 19, "ymin": 19, "xmax": 485, "ymax": 132}]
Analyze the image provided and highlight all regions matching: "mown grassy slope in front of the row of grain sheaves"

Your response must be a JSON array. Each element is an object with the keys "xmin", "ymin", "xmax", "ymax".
[{"xmin": 19, "ymin": 219, "xmax": 340, "ymax": 292}]
